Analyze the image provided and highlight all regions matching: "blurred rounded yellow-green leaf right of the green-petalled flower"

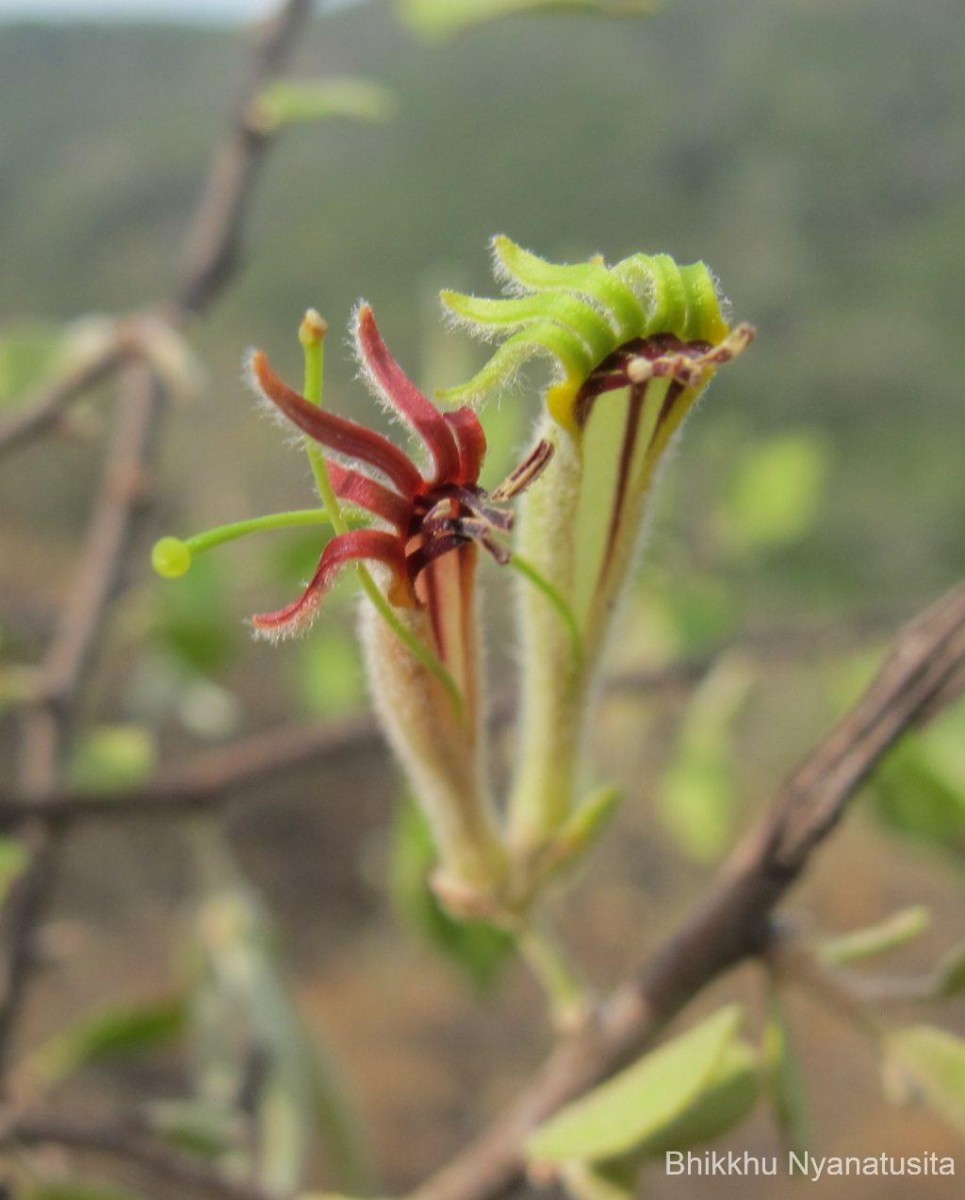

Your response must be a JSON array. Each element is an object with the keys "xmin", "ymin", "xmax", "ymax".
[{"xmin": 724, "ymin": 432, "xmax": 829, "ymax": 547}]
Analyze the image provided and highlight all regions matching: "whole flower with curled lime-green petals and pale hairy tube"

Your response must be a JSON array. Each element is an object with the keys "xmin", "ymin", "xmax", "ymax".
[{"xmin": 443, "ymin": 238, "xmax": 754, "ymax": 878}]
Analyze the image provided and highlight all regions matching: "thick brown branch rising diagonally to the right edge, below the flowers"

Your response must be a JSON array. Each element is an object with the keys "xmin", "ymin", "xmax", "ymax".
[{"xmin": 413, "ymin": 584, "xmax": 965, "ymax": 1200}]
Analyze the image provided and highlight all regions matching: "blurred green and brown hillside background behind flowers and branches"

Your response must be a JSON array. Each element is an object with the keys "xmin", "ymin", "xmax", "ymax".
[{"xmin": 0, "ymin": 0, "xmax": 965, "ymax": 1200}]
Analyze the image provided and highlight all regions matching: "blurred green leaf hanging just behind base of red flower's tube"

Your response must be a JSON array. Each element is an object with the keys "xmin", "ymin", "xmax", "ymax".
[{"xmin": 389, "ymin": 798, "xmax": 513, "ymax": 991}]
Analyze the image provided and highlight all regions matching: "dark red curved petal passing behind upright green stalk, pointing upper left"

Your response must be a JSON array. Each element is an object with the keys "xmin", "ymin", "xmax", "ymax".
[{"xmin": 251, "ymin": 350, "xmax": 424, "ymax": 497}]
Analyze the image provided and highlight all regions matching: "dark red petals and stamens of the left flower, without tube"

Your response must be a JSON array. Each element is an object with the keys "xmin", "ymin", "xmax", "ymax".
[{"xmin": 244, "ymin": 305, "xmax": 552, "ymax": 656}]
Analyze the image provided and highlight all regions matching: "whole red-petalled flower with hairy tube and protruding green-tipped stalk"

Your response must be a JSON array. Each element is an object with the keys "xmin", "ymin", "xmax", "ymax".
[{"xmin": 155, "ymin": 304, "xmax": 552, "ymax": 908}]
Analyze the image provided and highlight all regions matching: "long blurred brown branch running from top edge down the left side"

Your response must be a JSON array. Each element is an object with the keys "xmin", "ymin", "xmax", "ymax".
[{"xmin": 0, "ymin": 0, "xmax": 311, "ymax": 1089}]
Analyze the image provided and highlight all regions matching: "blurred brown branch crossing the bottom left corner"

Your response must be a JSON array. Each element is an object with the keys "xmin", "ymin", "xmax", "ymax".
[{"xmin": 0, "ymin": 1114, "xmax": 269, "ymax": 1200}]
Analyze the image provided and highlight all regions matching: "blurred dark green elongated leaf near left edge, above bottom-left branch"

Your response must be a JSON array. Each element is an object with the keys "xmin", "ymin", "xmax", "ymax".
[{"xmin": 26, "ymin": 996, "xmax": 187, "ymax": 1087}]
